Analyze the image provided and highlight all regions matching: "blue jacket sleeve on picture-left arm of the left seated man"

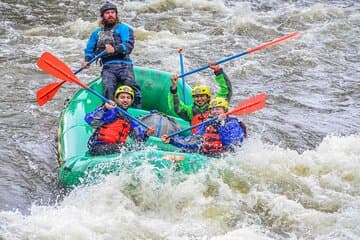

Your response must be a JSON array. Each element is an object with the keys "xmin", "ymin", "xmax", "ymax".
[{"xmin": 85, "ymin": 106, "xmax": 117, "ymax": 128}]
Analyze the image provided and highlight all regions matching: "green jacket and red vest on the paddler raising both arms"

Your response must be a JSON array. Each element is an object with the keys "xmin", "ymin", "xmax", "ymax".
[{"xmin": 168, "ymin": 68, "xmax": 232, "ymax": 133}]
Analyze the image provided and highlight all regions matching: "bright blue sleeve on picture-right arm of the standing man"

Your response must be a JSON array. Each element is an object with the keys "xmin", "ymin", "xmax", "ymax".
[{"xmin": 115, "ymin": 23, "xmax": 135, "ymax": 56}]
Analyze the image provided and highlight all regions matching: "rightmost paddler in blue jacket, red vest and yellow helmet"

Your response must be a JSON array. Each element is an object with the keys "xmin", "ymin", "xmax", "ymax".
[{"xmin": 161, "ymin": 98, "xmax": 246, "ymax": 156}]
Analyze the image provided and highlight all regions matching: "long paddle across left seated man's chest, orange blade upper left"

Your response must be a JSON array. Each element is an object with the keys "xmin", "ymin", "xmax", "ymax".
[{"xmin": 37, "ymin": 52, "xmax": 148, "ymax": 128}]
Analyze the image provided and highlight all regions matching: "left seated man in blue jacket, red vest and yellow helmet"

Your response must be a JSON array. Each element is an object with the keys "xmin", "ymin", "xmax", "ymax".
[{"xmin": 85, "ymin": 85, "xmax": 154, "ymax": 155}]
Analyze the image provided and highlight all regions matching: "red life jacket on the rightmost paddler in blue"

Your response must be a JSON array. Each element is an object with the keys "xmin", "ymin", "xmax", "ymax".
[{"xmin": 201, "ymin": 125, "xmax": 225, "ymax": 153}]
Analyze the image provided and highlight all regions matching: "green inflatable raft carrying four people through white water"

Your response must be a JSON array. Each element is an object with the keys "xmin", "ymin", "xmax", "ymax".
[{"xmin": 58, "ymin": 67, "xmax": 209, "ymax": 187}]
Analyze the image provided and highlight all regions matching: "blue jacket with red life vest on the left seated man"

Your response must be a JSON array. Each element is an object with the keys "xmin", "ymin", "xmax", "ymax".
[{"xmin": 85, "ymin": 106, "xmax": 148, "ymax": 149}]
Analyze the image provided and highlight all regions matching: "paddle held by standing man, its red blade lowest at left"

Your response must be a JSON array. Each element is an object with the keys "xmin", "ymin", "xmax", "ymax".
[{"xmin": 36, "ymin": 50, "xmax": 106, "ymax": 106}]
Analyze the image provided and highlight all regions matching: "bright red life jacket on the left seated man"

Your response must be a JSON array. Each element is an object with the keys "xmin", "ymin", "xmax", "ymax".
[{"xmin": 98, "ymin": 118, "xmax": 131, "ymax": 144}]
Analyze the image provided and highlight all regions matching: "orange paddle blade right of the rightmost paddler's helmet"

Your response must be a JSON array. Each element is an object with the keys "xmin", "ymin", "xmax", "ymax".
[{"xmin": 226, "ymin": 93, "xmax": 266, "ymax": 115}]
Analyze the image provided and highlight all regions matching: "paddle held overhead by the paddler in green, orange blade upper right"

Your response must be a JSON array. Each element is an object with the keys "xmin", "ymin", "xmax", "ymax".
[{"xmin": 179, "ymin": 32, "xmax": 300, "ymax": 78}]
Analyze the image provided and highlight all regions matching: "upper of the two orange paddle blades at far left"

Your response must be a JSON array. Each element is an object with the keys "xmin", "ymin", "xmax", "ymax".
[{"xmin": 37, "ymin": 52, "xmax": 88, "ymax": 89}]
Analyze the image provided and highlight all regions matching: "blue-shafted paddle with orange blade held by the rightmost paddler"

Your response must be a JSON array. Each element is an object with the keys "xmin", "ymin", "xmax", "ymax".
[{"xmin": 168, "ymin": 93, "xmax": 266, "ymax": 138}]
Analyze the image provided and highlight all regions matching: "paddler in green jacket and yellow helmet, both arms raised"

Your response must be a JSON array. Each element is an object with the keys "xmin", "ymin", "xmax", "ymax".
[{"xmin": 168, "ymin": 63, "xmax": 232, "ymax": 133}]
